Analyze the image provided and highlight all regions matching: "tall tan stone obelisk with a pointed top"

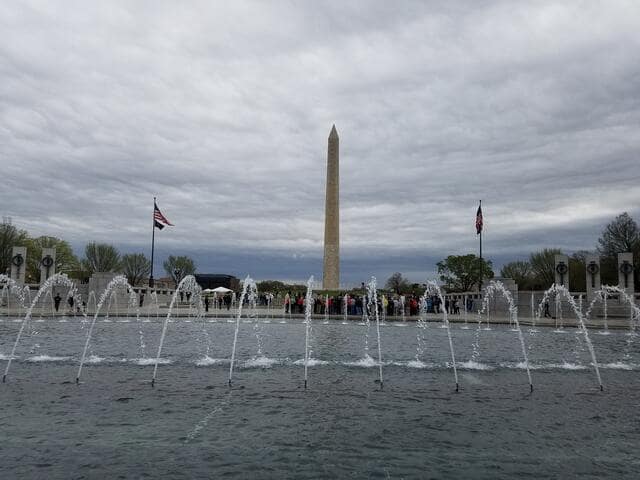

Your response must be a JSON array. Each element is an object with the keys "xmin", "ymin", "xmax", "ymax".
[{"xmin": 322, "ymin": 125, "xmax": 340, "ymax": 290}]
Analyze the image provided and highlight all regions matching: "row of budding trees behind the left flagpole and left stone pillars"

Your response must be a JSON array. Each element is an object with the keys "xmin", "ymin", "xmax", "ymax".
[{"xmin": 0, "ymin": 223, "xmax": 196, "ymax": 286}]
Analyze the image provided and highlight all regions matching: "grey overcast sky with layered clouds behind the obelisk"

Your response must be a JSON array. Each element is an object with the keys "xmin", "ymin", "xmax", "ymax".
[{"xmin": 0, "ymin": 0, "xmax": 640, "ymax": 282}]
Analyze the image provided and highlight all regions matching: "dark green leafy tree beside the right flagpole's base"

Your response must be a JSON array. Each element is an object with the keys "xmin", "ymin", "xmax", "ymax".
[{"xmin": 436, "ymin": 253, "xmax": 493, "ymax": 292}]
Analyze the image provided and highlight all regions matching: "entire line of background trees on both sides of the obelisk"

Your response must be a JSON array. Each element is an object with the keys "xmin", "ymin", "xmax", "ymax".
[{"xmin": 0, "ymin": 212, "xmax": 640, "ymax": 294}]
